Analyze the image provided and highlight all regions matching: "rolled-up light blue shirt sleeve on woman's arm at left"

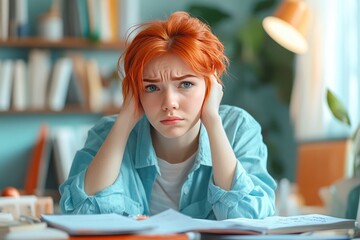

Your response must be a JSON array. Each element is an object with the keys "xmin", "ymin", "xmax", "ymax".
[{"xmin": 59, "ymin": 118, "xmax": 143, "ymax": 214}]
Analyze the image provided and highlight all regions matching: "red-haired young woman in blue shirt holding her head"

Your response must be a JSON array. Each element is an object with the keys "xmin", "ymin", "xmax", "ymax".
[{"xmin": 60, "ymin": 12, "xmax": 276, "ymax": 220}]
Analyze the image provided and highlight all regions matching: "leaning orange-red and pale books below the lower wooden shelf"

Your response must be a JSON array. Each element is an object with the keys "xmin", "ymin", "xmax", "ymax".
[{"xmin": 24, "ymin": 124, "xmax": 91, "ymax": 196}]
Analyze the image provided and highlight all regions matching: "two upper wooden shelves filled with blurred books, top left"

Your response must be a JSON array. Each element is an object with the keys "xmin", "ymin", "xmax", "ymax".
[{"xmin": 0, "ymin": 0, "xmax": 126, "ymax": 115}]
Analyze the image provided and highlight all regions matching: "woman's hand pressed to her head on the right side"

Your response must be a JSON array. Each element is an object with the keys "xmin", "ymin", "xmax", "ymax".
[{"xmin": 201, "ymin": 75, "xmax": 223, "ymax": 127}]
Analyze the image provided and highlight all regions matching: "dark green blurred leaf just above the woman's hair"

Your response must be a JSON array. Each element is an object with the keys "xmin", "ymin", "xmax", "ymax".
[{"xmin": 188, "ymin": 4, "xmax": 230, "ymax": 28}]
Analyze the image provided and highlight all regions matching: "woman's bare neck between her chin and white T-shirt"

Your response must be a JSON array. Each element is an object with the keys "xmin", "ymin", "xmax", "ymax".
[{"xmin": 151, "ymin": 121, "xmax": 200, "ymax": 163}]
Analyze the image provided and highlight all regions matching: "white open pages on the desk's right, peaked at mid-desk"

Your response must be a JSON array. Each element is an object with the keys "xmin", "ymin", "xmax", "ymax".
[{"xmin": 142, "ymin": 209, "xmax": 354, "ymax": 234}]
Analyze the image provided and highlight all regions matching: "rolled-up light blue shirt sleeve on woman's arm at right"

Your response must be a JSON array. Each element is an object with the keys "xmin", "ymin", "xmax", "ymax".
[{"xmin": 208, "ymin": 108, "xmax": 276, "ymax": 220}]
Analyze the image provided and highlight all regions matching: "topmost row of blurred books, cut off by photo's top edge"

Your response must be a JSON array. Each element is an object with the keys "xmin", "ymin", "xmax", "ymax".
[{"xmin": 0, "ymin": 0, "xmax": 140, "ymax": 41}]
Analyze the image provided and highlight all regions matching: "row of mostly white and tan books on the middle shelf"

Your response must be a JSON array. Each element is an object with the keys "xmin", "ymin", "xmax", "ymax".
[{"xmin": 0, "ymin": 49, "xmax": 122, "ymax": 112}]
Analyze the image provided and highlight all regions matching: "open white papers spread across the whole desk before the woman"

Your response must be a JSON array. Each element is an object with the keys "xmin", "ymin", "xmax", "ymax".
[{"xmin": 42, "ymin": 209, "xmax": 355, "ymax": 235}]
